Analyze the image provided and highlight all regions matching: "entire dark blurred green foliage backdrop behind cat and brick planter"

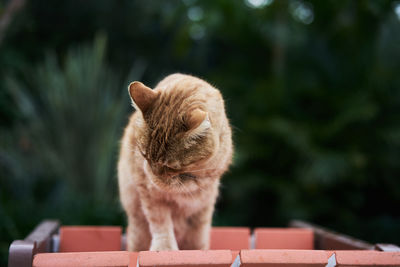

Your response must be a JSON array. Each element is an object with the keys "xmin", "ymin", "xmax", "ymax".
[{"xmin": 0, "ymin": 0, "xmax": 400, "ymax": 264}]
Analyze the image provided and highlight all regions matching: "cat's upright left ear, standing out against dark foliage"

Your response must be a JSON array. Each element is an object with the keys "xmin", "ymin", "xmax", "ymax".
[{"xmin": 128, "ymin": 82, "xmax": 158, "ymax": 113}]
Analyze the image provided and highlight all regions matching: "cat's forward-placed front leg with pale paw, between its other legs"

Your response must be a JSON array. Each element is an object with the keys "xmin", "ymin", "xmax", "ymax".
[{"xmin": 141, "ymin": 203, "xmax": 178, "ymax": 251}]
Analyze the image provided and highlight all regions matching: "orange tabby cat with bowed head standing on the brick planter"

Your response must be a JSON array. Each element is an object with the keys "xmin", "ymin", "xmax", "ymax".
[{"xmin": 118, "ymin": 74, "xmax": 232, "ymax": 251}]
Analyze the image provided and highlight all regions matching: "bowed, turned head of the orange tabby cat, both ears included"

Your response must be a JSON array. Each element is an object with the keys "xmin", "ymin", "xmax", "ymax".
[{"xmin": 129, "ymin": 82, "xmax": 218, "ymax": 191}]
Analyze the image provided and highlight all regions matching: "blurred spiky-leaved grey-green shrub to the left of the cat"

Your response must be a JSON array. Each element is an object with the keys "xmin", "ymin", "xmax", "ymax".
[{"xmin": 0, "ymin": 35, "xmax": 143, "ymax": 264}]
